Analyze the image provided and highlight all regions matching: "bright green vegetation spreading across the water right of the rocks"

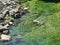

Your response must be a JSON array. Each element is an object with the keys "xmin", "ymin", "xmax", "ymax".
[{"xmin": 14, "ymin": 0, "xmax": 60, "ymax": 45}]
